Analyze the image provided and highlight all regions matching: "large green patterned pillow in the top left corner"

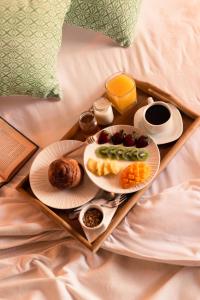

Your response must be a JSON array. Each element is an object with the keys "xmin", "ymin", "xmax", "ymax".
[{"xmin": 0, "ymin": 0, "xmax": 71, "ymax": 97}]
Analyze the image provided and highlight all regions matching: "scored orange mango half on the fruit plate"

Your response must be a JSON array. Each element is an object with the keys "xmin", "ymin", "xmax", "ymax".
[{"xmin": 120, "ymin": 162, "xmax": 151, "ymax": 189}]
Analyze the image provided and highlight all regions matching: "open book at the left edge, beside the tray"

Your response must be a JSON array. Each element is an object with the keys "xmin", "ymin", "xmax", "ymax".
[{"xmin": 0, "ymin": 117, "xmax": 38, "ymax": 186}]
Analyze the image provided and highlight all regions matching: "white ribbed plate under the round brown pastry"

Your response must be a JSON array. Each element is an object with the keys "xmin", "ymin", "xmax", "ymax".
[{"xmin": 30, "ymin": 140, "xmax": 98, "ymax": 209}]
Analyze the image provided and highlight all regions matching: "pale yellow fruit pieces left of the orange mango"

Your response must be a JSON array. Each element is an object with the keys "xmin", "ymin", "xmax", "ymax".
[{"xmin": 87, "ymin": 158, "xmax": 121, "ymax": 176}]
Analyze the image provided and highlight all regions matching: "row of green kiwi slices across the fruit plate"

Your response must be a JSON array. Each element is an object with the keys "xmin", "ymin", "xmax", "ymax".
[{"xmin": 95, "ymin": 146, "xmax": 149, "ymax": 161}]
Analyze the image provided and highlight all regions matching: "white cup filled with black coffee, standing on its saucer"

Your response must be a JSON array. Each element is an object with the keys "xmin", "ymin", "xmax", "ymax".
[{"xmin": 143, "ymin": 97, "xmax": 172, "ymax": 134}]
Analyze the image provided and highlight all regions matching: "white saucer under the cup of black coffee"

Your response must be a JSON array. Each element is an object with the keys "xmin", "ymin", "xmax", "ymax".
[{"xmin": 133, "ymin": 104, "xmax": 183, "ymax": 145}]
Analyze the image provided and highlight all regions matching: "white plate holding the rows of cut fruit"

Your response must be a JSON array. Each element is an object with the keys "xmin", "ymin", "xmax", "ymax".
[{"xmin": 84, "ymin": 125, "xmax": 160, "ymax": 194}]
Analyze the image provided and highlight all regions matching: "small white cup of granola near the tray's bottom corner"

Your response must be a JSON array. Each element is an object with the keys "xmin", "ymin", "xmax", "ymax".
[{"xmin": 79, "ymin": 204, "xmax": 105, "ymax": 230}]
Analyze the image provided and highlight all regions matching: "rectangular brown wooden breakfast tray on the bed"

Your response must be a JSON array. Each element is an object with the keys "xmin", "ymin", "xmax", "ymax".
[{"xmin": 17, "ymin": 80, "xmax": 200, "ymax": 252}]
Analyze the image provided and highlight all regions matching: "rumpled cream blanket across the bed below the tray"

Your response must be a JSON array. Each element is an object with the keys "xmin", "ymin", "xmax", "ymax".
[{"xmin": 0, "ymin": 170, "xmax": 200, "ymax": 300}]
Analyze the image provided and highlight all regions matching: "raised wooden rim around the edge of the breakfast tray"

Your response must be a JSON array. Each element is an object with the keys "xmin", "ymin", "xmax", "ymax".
[{"xmin": 15, "ymin": 79, "xmax": 200, "ymax": 252}]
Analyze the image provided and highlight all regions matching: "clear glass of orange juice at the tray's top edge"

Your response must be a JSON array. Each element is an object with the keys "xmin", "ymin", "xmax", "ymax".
[{"xmin": 106, "ymin": 72, "xmax": 137, "ymax": 114}]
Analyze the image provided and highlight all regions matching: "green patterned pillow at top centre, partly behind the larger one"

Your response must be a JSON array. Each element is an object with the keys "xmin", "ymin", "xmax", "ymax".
[{"xmin": 65, "ymin": 0, "xmax": 141, "ymax": 47}]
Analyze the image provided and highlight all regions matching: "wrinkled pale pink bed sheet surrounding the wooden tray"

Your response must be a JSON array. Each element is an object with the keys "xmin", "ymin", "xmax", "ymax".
[{"xmin": 0, "ymin": 0, "xmax": 200, "ymax": 300}]
